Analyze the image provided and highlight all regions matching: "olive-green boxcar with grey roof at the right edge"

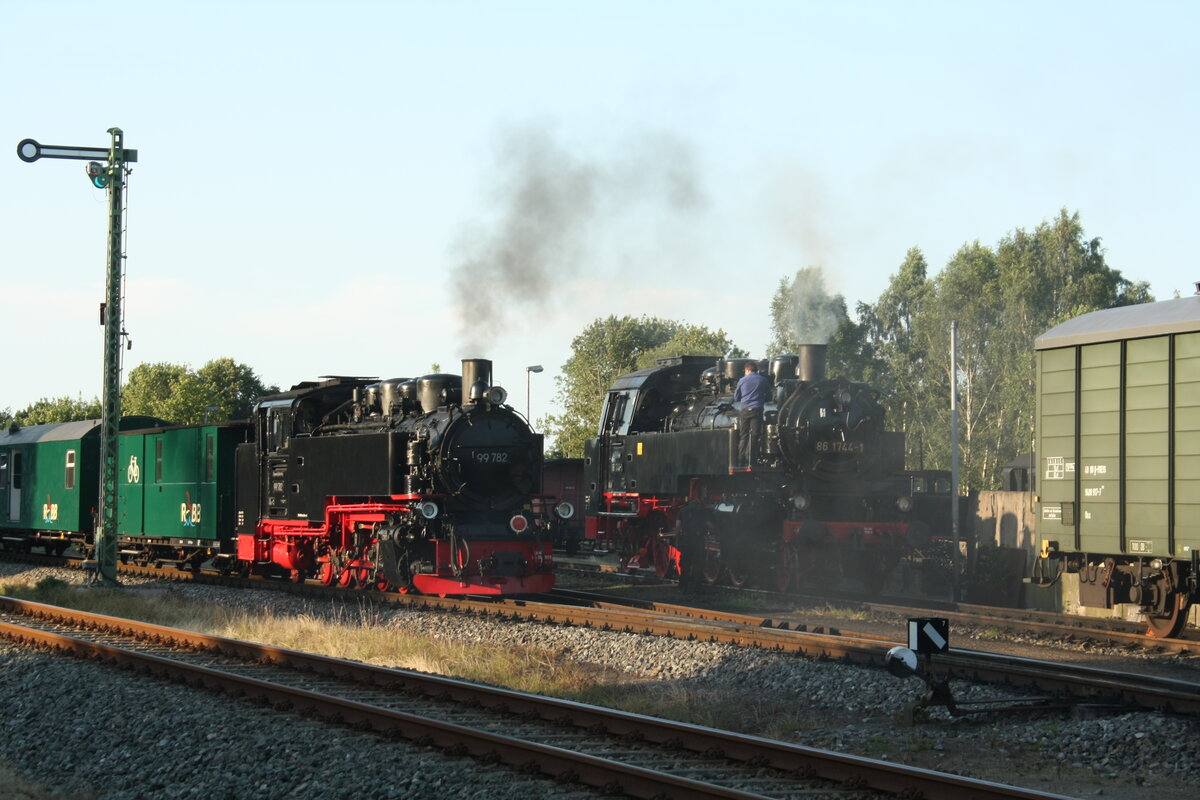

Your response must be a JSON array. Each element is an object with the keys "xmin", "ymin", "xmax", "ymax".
[{"xmin": 1034, "ymin": 296, "xmax": 1200, "ymax": 636}]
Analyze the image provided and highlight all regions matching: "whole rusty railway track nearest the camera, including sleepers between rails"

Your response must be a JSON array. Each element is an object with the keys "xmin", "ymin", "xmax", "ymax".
[{"xmin": 0, "ymin": 597, "xmax": 1075, "ymax": 800}]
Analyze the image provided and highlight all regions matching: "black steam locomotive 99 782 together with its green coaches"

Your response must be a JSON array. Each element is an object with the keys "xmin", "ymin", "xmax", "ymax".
[{"xmin": 0, "ymin": 359, "xmax": 572, "ymax": 595}]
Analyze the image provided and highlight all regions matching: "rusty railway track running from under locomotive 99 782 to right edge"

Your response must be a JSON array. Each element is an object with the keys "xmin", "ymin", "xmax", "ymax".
[{"xmin": 9, "ymin": 557, "xmax": 1200, "ymax": 714}]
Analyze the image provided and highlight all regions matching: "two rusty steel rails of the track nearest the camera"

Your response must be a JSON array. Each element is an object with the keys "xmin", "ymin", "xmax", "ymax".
[{"xmin": 0, "ymin": 597, "xmax": 1061, "ymax": 800}]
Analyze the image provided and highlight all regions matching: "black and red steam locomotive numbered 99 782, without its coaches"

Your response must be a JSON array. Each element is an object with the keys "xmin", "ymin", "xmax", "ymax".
[{"xmin": 236, "ymin": 359, "xmax": 571, "ymax": 595}]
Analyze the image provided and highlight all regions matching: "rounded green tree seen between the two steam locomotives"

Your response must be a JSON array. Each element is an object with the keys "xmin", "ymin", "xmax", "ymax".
[{"xmin": 539, "ymin": 315, "xmax": 740, "ymax": 457}]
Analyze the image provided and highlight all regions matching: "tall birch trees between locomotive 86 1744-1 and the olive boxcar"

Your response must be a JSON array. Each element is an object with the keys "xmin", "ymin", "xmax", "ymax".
[{"xmin": 859, "ymin": 210, "xmax": 1152, "ymax": 489}]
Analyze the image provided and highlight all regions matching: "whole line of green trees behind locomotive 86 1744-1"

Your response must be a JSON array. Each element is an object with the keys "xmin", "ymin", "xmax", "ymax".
[{"xmin": 539, "ymin": 209, "xmax": 1153, "ymax": 489}]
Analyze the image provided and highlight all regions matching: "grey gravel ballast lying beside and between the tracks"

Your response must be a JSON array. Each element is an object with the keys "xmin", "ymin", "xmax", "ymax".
[{"xmin": 0, "ymin": 563, "xmax": 1200, "ymax": 800}]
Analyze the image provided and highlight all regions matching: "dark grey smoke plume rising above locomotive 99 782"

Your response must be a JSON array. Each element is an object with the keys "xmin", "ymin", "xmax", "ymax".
[{"xmin": 450, "ymin": 127, "xmax": 704, "ymax": 351}]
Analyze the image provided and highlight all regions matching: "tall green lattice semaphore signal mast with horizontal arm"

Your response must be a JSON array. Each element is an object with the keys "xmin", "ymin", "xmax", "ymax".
[{"xmin": 17, "ymin": 128, "xmax": 138, "ymax": 585}]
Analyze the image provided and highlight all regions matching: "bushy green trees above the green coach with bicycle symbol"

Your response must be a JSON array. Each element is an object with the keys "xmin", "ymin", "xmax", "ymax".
[{"xmin": 121, "ymin": 359, "xmax": 280, "ymax": 425}]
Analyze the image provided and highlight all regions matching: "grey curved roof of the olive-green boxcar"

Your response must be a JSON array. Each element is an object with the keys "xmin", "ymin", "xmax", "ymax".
[{"xmin": 1033, "ymin": 296, "xmax": 1200, "ymax": 350}]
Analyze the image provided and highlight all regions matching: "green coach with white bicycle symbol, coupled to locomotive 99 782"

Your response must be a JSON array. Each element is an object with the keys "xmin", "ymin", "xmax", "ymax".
[{"xmin": 118, "ymin": 422, "xmax": 250, "ymax": 555}]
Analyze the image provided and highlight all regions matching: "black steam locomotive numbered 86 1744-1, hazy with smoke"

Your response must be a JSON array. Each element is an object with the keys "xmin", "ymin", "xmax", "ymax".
[{"xmin": 584, "ymin": 345, "xmax": 950, "ymax": 591}]
